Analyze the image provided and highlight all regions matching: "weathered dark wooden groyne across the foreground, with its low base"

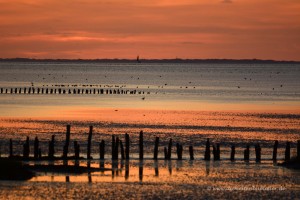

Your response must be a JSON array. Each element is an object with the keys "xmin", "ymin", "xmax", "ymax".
[{"xmin": 0, "ymin": 125, "xmax": 300, "ymax": 163}]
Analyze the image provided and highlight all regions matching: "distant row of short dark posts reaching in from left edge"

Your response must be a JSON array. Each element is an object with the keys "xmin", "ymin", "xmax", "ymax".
[{"xmin": 0, "ymin": 87, "xmax": 150, "ymax": 94}]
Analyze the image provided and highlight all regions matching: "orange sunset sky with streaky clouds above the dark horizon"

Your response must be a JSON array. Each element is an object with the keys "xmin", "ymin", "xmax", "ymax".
[{"xmin": 0, "ymin": 0, "xmax": 300, "ymax": 61}]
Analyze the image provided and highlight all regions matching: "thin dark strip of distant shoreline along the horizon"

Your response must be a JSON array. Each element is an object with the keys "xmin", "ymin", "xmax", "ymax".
[{"xmin": 0, "ymin": 58, "xmax": 300, "ymax": 64}]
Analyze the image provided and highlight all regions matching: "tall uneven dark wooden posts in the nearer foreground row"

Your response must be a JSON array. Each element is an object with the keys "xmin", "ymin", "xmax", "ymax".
[{"xmin": 0, "ymin": 125, "xmax": 300, "ymax": 162}]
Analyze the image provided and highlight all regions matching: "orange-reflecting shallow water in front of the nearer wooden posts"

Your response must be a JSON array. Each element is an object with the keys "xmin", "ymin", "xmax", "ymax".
[{"xmin": 0, "ymin": 160, "xmax": 300, "ymax": 199}]
